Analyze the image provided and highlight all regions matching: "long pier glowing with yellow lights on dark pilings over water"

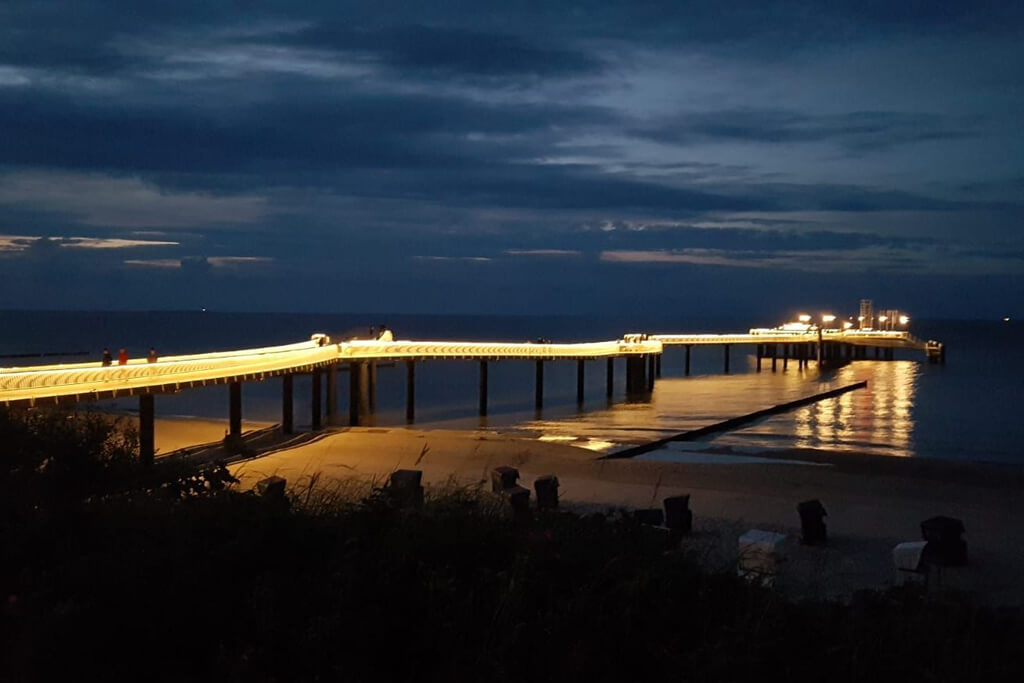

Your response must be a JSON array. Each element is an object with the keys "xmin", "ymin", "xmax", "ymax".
[{"xmin": 0, "ymin": 326, "xmax": 945, "ymax": 460}]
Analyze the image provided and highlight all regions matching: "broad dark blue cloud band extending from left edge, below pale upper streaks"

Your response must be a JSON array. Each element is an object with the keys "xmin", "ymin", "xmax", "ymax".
[{"xmin": 0, "ymin": 84, "xmax": 614, "ymax": 172}]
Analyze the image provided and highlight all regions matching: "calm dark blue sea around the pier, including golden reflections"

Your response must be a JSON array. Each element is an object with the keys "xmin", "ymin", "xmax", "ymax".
[{"xmin": 0, "ymin": 311, "xmax": 1024, "ymax": 462}]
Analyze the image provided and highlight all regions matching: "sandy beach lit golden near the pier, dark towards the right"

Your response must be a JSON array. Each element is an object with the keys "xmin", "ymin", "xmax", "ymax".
[{"xmin": 149, "ymin": 420, "xmax": 1024, "ymax": 604}]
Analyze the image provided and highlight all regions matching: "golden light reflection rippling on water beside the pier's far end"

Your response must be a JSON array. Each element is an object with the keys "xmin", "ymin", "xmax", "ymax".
[{"xmin": 521, "ymin": 360, "xmax": 921, "ymax": 457}]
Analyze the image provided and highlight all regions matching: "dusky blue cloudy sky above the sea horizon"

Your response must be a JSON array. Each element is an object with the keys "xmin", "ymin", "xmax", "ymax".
[{"xmin": 0, "ymin": 0, "xmax": 1024, "ymax": 317}]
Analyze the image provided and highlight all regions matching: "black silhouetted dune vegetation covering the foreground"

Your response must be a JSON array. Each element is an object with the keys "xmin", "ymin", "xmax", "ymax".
[{"xmin": 0, "ymin": 414, "xmax": 1024, "ymax": 681}]
